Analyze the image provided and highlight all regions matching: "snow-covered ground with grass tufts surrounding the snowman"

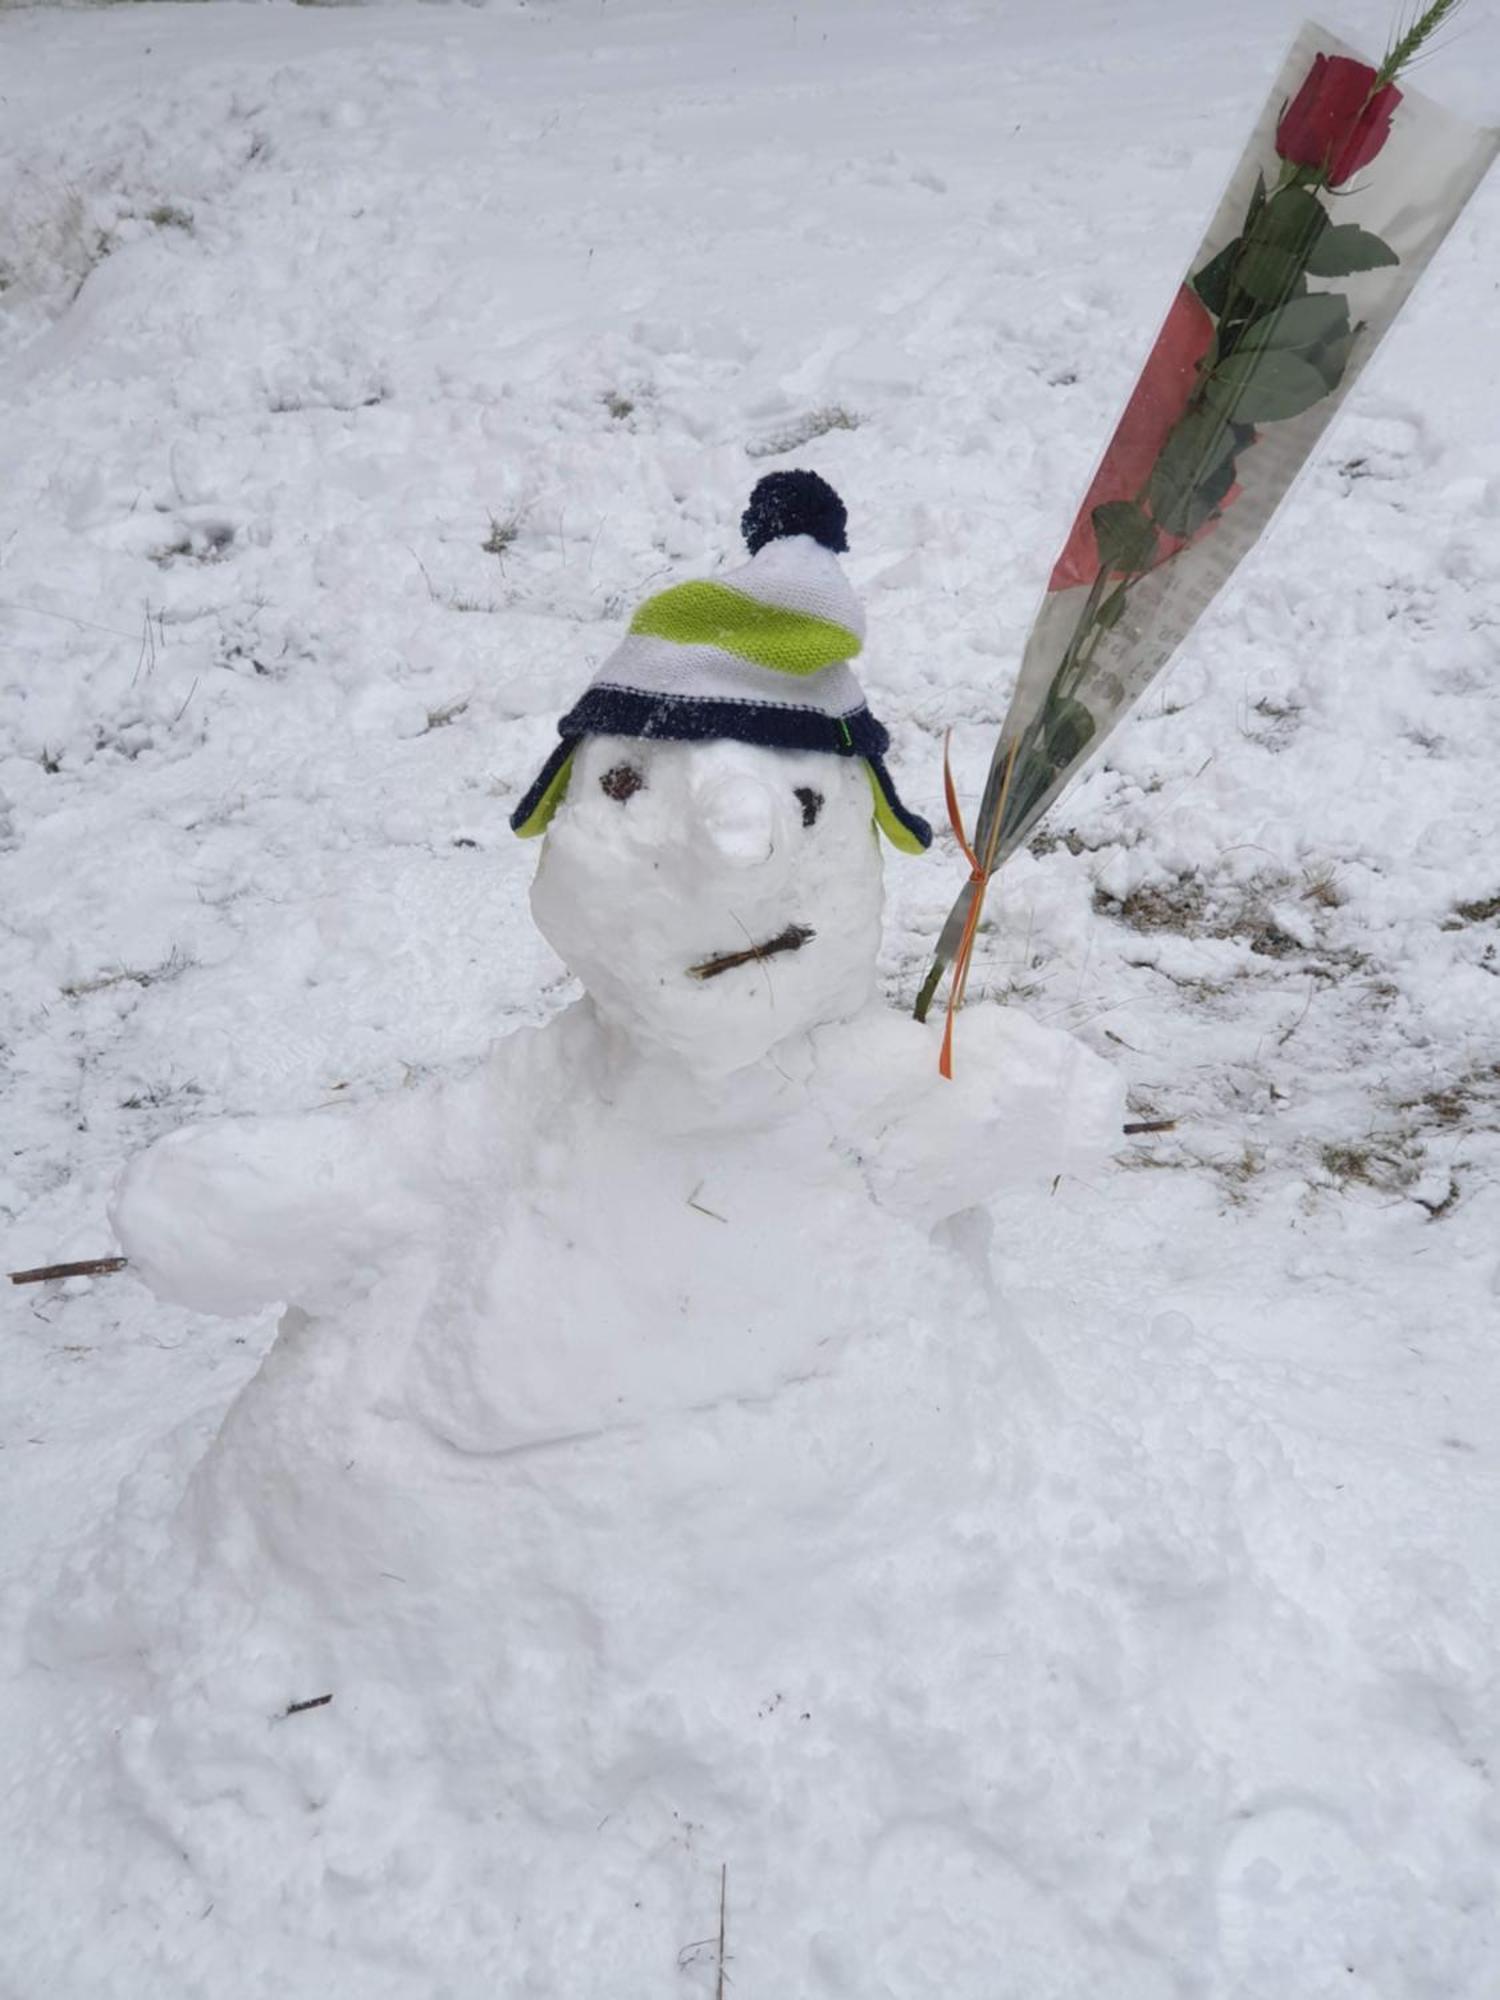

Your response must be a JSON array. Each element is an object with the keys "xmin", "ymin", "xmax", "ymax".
[{"xmin": 0, "ymin": 0, "xmax": 1500, "ymax": 2000}]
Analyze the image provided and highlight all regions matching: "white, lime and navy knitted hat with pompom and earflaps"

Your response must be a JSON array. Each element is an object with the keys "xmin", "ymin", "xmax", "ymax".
[{"xmin": 510, "ymin": 472, "xmax": 932, "ymax": 854}]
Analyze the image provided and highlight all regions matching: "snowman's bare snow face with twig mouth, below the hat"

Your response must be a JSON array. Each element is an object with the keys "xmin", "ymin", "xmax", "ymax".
[{"xmin": 532, "ymin": 736, "xmax": 882, "ymax": 1074}]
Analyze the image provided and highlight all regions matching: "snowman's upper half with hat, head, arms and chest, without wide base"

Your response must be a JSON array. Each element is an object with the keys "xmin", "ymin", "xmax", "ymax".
[{"xmin": 114, "ymin": 472, "xmax": 1120, "ymax": 1424}]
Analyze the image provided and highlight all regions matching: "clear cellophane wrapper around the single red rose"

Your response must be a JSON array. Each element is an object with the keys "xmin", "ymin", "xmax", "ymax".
[{"xmin": 924, "ymin": 22, "xmax": 1500, "ymax": 984}]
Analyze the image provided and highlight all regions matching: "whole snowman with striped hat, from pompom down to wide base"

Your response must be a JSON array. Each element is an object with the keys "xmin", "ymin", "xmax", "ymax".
[{"xmin": 88, "ymin": 472, "xmax": 1120, "ymax": 1990}]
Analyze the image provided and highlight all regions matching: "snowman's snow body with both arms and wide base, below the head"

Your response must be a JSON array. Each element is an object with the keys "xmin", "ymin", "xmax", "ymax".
[{"xmin": 44, "ymin": 1002, "xmax": 1122, "ymax": 1992}]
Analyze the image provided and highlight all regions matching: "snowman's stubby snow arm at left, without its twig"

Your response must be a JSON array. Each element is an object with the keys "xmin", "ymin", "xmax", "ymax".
[{"xmin": 110, "ymin": 1094, "xmax": 434, "ymax": 1316}]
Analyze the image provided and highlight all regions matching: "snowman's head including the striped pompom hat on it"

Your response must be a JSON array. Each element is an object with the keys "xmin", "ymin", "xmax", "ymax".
[{"xmin": 510, "ymin": 472, "xmax": 932, "ymax": 1070}]
